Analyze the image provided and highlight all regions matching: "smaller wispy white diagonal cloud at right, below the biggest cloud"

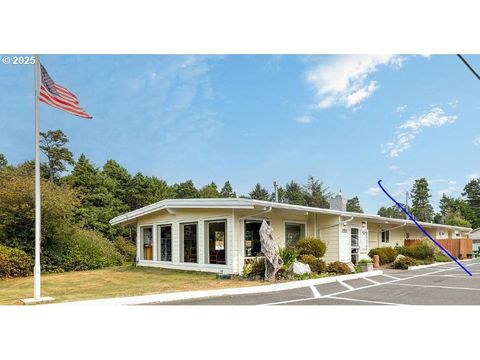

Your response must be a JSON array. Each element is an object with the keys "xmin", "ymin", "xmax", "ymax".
[{"xmin": 382, "ymin": 106, "xmax": 457, "ymax": 157}]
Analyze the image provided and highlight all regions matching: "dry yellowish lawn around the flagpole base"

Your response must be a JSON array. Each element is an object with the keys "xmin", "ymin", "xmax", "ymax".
[{"xmin": 0, "ymin": 265, "xmax": 265, "ymax": 305}]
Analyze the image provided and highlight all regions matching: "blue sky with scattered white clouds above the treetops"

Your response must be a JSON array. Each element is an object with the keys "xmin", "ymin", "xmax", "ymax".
[{"xmin": 0, "ymin": 55, "xmax": 480, "ymax": 213}]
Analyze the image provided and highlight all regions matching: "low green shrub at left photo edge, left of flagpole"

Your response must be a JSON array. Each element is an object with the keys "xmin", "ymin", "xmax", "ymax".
[{"xmin": 0, "ymin": 245, "xmax": 33, "ymax": 279}]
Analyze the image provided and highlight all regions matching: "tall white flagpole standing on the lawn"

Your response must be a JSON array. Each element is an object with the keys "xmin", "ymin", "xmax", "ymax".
[{"xmin": 33, "ymin": 55, "xmax": 42, "ymax": 301}]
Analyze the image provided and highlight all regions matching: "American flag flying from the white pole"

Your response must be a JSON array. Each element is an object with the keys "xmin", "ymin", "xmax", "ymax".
[{"xmin": 39, "ymin": 64, "xmax": 92, "ymax": 119}]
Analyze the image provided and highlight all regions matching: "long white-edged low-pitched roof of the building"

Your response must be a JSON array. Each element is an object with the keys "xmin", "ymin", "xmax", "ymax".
[{"xmin": 110, "ymin": 198, "xmax": 472, "ymax": 231}]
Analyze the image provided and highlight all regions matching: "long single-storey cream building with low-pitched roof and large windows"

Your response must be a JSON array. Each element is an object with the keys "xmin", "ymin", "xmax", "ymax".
[{"xmin": 110, "ymin": 194, "xmax": 471, "ymax": 274}]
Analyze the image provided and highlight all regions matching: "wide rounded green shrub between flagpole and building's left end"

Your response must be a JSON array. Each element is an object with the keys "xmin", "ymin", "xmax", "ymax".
[{"xmin": 43, "ymin": 229, "xmax": 125, "ymax": 272}]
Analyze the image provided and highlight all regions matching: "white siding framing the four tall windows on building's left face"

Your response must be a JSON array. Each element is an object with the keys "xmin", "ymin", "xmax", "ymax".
[{"xmin": 137, "ymin": 209, "xmax": 238, "ymax": 274}]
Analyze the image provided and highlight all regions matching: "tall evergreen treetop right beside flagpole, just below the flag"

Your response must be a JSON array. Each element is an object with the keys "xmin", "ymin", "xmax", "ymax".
[{"xmin": 40, "ymin": 130, "xmax": 75, "ymax": 181}]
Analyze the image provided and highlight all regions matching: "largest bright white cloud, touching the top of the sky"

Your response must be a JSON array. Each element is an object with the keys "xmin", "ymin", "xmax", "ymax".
[{"xmin": 307, "ymin": 55, "xmax": 404, "ymax": 109}]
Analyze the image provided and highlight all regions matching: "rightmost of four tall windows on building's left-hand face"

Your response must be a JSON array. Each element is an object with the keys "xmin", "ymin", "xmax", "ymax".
[{"xmin": 205, "ymin": 220, "xmax": 227, "ymax": 265}]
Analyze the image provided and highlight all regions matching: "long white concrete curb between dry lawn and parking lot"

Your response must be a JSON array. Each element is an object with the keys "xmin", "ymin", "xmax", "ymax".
[{"xmin": 50, "ymin": 270, "xmax": 383, "ymax": 306}]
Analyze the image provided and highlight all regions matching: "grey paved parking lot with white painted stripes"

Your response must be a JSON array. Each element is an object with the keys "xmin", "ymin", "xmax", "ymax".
[{"xmin": 155, "ymin": 260, "xmax": 480, "ymax": 306}]
